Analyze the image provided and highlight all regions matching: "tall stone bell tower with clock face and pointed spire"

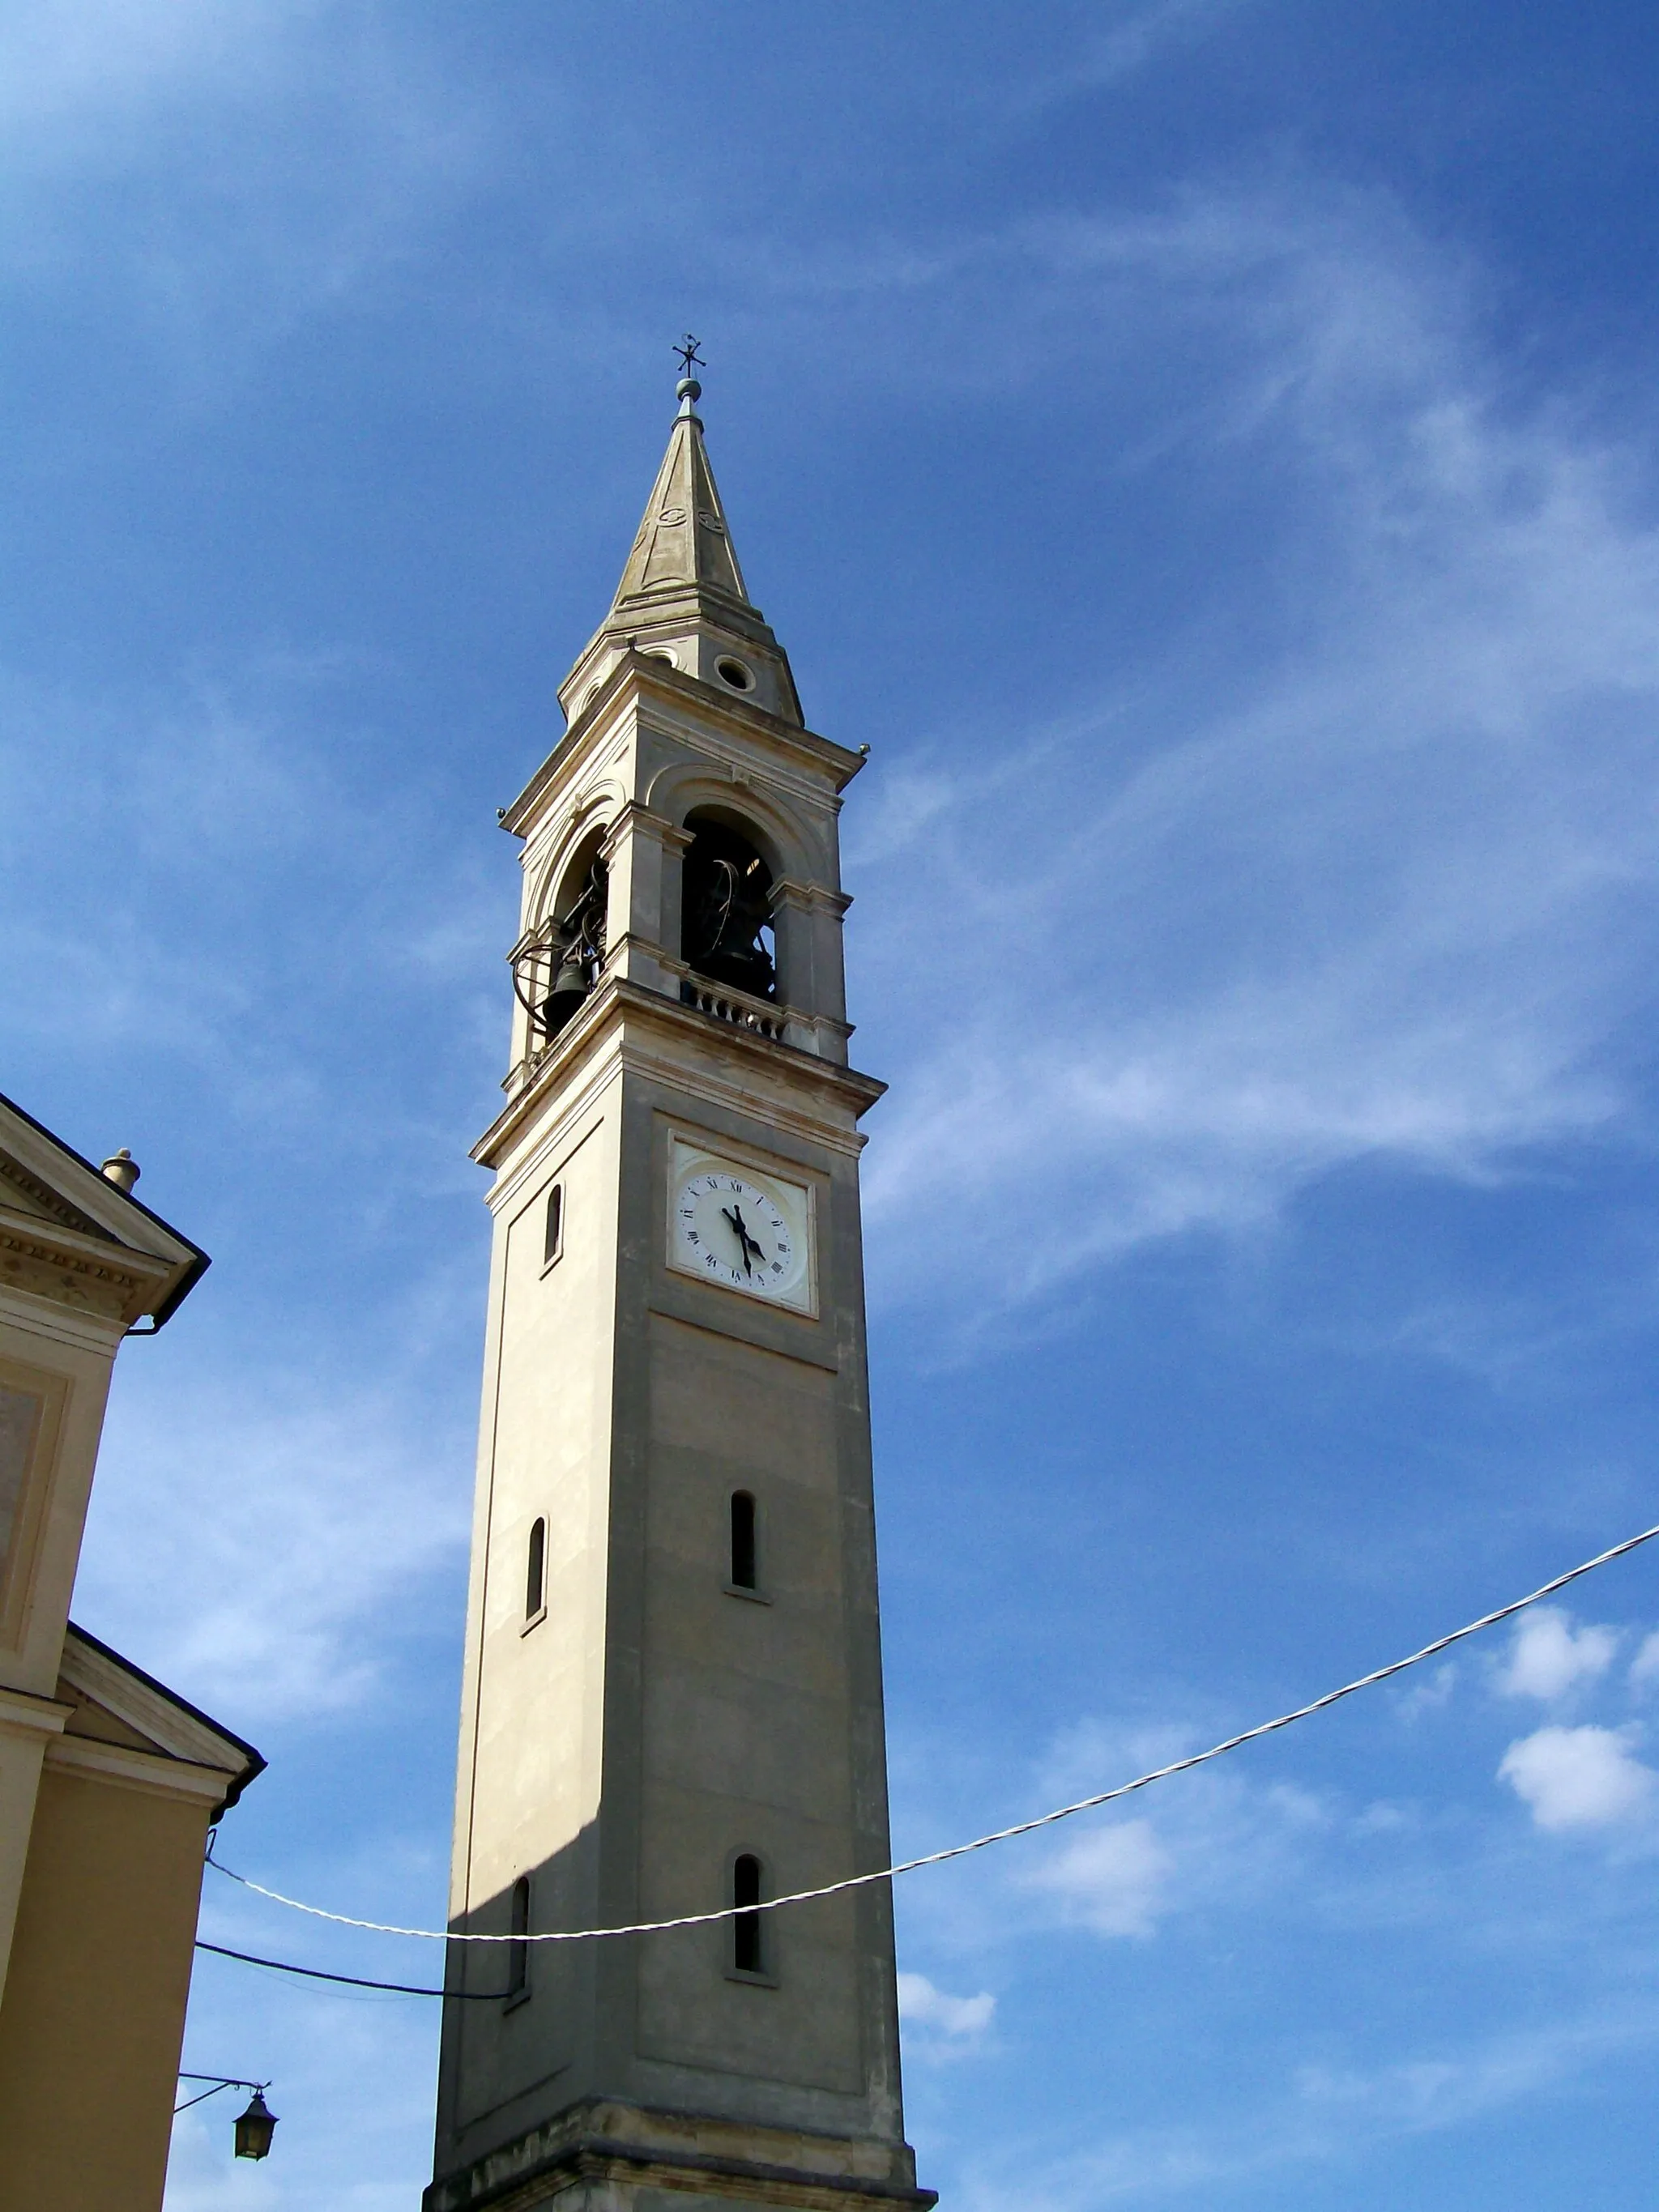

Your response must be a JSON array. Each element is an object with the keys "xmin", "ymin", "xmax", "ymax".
[{"xmin": 424, "ymin": 376, "xmax": 933, "ymax": 2212}]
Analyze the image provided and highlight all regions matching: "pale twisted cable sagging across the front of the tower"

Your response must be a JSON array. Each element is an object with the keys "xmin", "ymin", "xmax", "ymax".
[{"xmin": 208, "ymin": 1522, "xmax": 1659, "ymax": 1945}]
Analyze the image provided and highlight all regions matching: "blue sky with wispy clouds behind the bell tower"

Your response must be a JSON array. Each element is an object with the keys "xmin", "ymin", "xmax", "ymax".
[{"xmin": 0, "ymin": 0, "xmax": 1659, "ymax": 2212}]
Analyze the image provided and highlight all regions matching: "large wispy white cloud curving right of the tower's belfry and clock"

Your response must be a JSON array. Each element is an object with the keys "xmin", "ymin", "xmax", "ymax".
[{"xmin": 847, "ymin": 197, "xmax": 1659, "ymax": 1311}]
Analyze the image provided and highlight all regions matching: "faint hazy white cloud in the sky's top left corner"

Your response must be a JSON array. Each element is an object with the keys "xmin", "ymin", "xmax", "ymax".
[{"xmin": 0, "ymin": 0, "xmax": 488, "ymax": 403}]
